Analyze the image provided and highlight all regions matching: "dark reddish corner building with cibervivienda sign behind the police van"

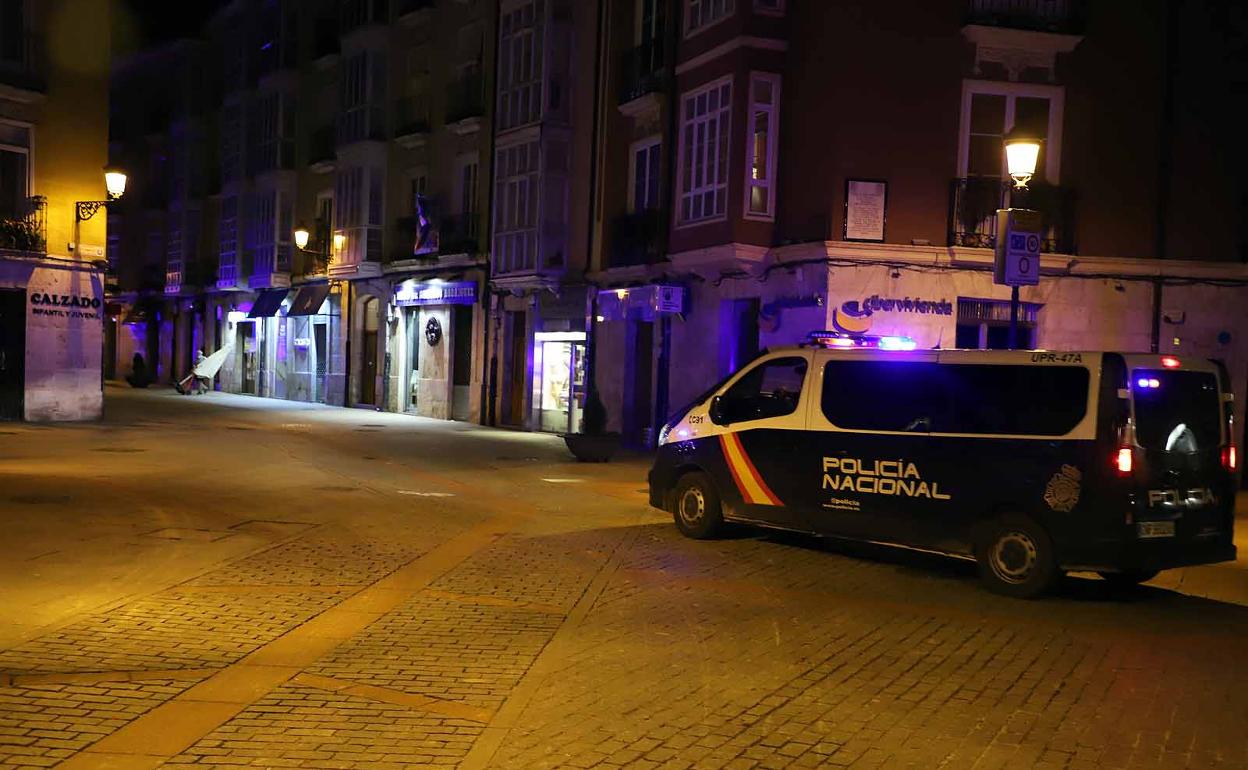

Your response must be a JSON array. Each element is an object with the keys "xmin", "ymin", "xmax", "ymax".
[{"xmin": 590, "ymin": 0, "xmax": 1248, "ymax": 443}]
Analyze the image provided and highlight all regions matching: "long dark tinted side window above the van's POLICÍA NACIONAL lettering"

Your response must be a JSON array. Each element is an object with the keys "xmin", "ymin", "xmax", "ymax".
[{"xmin": 822, "ymin": 361, "xmax": 1090, "ymax": 436}]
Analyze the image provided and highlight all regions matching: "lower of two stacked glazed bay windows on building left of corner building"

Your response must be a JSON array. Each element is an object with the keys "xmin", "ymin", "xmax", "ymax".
[{"xmin": 494, "ymin": 142, "xmax": 539, "ymax": 273}]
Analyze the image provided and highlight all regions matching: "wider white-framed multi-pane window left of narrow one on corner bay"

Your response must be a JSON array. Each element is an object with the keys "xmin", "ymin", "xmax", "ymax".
[{"xmin": 680, "ymin": 77, "xmax": 733, "ymax": 223}]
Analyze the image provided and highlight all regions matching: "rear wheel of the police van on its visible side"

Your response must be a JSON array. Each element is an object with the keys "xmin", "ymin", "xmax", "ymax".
[{"xmin": 975, "ymin": 513, "xmax": 1062, "ymax": 599}]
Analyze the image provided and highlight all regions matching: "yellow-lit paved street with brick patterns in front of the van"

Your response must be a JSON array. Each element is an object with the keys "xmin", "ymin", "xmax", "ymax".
[{"xmin": 0, "ymin": 387, "xmax": 1248, "ymax": 770}]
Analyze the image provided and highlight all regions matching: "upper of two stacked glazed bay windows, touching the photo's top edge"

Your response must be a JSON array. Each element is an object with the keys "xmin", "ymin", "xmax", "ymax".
[{"xmin": 498, "ymin": 0, "xmax": 544, "ymax": 131}]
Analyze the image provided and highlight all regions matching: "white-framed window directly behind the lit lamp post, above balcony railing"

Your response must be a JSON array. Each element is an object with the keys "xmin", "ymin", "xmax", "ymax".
[{"xmin": 958, "ymin": 80, "xmax": 1063, "ymax": 183}]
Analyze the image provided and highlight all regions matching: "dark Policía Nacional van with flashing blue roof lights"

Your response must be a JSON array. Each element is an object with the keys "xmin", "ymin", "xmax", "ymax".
[{"xmin": 649, "ymin": 332, "xmax": 1238, "ymax": 597}]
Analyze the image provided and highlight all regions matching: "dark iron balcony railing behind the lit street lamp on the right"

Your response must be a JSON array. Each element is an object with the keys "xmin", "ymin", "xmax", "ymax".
[{"xmin": 948, "ymin": 177, "xmax": 1077, "ymax": 255}]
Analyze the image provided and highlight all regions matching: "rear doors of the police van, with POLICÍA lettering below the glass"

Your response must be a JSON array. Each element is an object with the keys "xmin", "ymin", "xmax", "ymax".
[{"xmin": 1127, "ymin": 356, "xmax": 1234, "ymax": 540}]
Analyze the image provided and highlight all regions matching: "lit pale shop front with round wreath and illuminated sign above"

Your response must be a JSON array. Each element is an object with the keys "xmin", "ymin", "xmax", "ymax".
[{"xmin": 392, "ymin": 278, "xmax": 484, "ymax": 422}]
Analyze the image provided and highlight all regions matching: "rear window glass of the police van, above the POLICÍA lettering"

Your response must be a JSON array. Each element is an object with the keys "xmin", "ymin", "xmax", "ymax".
[{"xmin": 1131, "ymin": 369, "xmax": 1222, "ymax": 454}]
